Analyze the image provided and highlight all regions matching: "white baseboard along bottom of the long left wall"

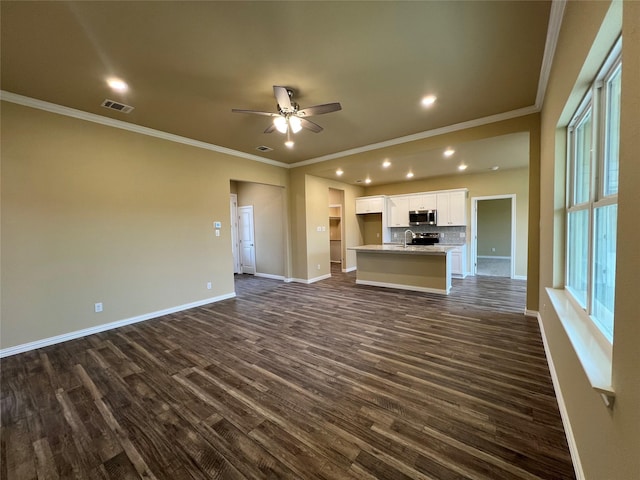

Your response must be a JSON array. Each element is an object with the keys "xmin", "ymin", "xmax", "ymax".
[{"xmin": 0, "ymin": 292, "xmax": 236, "ymax": 358}]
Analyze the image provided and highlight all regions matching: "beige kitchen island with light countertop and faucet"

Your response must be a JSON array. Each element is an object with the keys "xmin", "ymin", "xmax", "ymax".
[{"xmin": 348, "ymin": 245, "xmax": 456, "ymax": 295}]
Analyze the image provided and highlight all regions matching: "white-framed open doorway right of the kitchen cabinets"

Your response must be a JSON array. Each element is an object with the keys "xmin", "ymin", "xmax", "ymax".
[{"xmin": 471, "ymin": 195, "xmax": 516, "ymax": 278}]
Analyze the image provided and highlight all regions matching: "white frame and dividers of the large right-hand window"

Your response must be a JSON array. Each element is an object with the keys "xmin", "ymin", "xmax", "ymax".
[{"xmin": 565, "ymin": 38, "xmax": 622, "ymax": 345}]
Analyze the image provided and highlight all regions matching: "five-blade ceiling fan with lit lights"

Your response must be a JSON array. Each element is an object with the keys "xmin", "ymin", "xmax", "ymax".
[{"xmin": 231, "ymin": 85, "xmax": 342, "ymax": 147}]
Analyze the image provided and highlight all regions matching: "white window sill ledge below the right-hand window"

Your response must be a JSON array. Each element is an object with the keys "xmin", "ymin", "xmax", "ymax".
[{"xmin": 546, "ymin": 288, "xmax": 616, "ymax": 407}]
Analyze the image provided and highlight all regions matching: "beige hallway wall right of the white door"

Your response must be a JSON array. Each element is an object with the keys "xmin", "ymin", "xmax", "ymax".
[{"xmin": 233, "ymin": 182, "xmax": 287, "ymax": 277}]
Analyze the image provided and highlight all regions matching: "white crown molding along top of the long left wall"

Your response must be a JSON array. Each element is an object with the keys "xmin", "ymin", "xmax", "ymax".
[{"xmin": 0, "ymin": 90, "xmax": 290, "ymax": 168}]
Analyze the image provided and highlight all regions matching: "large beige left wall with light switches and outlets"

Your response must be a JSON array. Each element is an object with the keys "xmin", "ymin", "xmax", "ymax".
[{"xmin": 0, "ymin": 102, "xmax": 288, "ymax": 348}]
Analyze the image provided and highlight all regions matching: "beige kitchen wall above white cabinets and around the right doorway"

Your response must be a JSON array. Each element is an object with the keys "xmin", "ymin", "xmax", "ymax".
[{"xmin": 366, "ymin": 168, "xmax": 537, "ymax": 278}]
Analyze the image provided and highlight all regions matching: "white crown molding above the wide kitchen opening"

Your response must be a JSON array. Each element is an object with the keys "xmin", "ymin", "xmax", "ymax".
[{"xmin": 289, "ymin": 105, "xmax": 540, "ymax": 168}]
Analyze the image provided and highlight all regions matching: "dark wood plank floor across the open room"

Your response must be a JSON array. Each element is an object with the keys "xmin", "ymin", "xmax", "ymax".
[{"xmin": 0, "ymin": 272, "xmax": 574, "ymax": 480}]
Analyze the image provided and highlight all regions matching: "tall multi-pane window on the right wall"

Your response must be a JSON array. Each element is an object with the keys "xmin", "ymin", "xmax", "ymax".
[{"xmin": 565, "ymin": 39, "xmax": 622, "ymax": 343}]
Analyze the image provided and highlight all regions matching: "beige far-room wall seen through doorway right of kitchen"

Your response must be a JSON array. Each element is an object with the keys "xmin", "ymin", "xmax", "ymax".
[{"xmin": 477, "ymin": 198, "xmax": 511, "ymax": 257}]
